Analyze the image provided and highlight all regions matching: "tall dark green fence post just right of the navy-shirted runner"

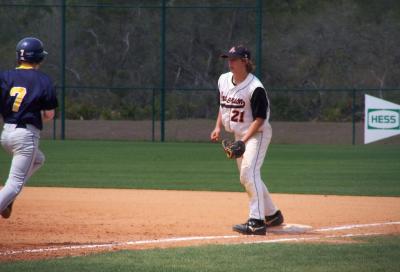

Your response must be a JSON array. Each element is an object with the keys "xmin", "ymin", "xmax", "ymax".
[{"xmin": 60, "ymin": 0, "xmax": 66, "ymax": 140}]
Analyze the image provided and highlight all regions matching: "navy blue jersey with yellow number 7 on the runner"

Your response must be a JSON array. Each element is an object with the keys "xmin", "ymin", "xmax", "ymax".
[{"xmin": 0, "ymin": 66, "xmax": 58, "ymax": 129}]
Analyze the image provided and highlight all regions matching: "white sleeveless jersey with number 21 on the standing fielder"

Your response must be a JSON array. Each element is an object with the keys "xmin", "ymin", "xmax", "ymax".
[{"xmin": 218, "ymin": 72, "xmax": 270, "ymax": 135}]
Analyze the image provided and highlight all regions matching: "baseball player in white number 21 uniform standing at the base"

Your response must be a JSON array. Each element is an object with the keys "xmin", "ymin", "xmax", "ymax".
[{"xmin": 210, "ymin": 46, "xmax": 284, "ymax": 235}]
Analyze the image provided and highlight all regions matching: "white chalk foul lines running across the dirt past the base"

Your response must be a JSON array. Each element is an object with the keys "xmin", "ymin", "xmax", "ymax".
[{"xmin": 0, "ymin": 222, "xmax": 400, "ymax": 256}]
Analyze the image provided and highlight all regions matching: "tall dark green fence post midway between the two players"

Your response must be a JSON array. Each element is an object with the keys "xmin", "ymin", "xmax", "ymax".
[{"xmin": 160, "ymin": 0, "xmax": 166, "ymax": 142}]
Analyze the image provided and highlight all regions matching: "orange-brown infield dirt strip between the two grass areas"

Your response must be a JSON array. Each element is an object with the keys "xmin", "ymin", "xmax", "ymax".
[{"xmin": 0, "ymin": 187, "xmax": 400, "ymax": 261}]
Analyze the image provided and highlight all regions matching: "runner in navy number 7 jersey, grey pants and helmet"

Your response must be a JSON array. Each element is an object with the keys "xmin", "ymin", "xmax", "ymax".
[{"xmin": 0, "ymin": 37, "xmax": 58, "ymax": 218}]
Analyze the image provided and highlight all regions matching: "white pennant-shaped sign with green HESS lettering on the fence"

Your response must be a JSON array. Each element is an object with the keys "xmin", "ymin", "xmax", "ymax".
[{"xmin": 364, "ymin": 94, "xmax": 400, "ymax": 144}]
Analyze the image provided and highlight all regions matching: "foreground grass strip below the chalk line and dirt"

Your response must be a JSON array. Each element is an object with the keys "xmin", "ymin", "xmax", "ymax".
[{"xmin": 0, "ymin": 236, "xmax": 400, "ymax": 272}]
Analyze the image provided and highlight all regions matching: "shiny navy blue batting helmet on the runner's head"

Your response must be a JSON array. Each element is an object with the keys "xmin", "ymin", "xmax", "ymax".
[{"xmin": 16, "ymin": 37, "xmax": 47, "ymax": 63}]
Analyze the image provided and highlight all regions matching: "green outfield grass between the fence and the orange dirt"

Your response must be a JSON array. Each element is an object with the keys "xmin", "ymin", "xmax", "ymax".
[{"xmin": 0, "ymin": 141, "xmax": 400, "ymax": 196}]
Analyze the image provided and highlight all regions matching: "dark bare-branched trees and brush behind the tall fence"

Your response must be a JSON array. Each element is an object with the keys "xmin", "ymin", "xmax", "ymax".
[{"xmin": 0, "ymin": 0, "xmax": 400, "ymax": 121}]
